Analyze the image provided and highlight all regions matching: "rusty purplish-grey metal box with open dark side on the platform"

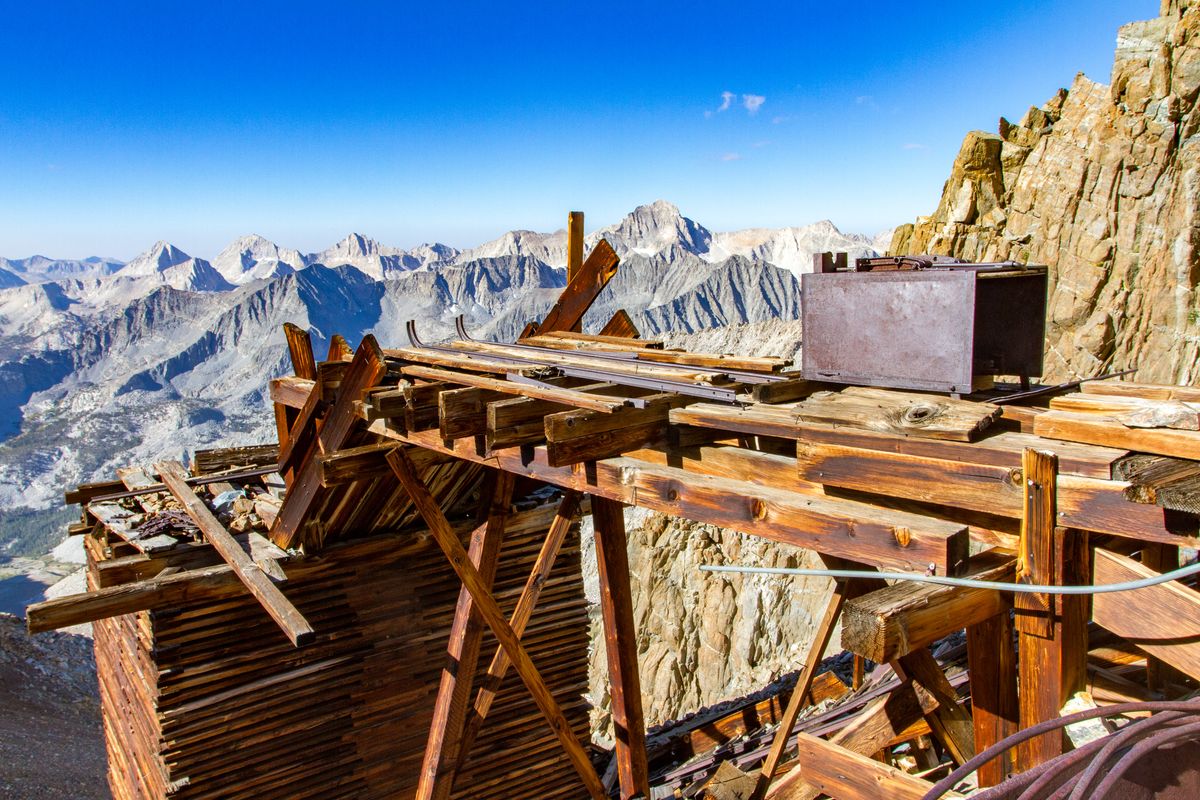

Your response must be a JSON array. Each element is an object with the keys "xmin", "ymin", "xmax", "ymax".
[{"xmin": 800, "ymin": 254, "xmax": 1046, "ymax": 395}]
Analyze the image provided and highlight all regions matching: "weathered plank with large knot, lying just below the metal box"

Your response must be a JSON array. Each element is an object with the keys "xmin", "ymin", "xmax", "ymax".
[{"xmin": 794, "ymin": 386, "xmax": 1001, "ymax": 441}]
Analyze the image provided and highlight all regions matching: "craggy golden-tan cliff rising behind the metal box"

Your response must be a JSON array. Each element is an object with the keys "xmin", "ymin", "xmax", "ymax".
[{"xmin": 890, "ymin": 0, "xmax": 1200, "ymax": 383}]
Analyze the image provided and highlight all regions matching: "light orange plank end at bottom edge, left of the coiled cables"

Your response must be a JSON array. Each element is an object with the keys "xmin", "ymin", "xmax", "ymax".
[{"xmin": 797, "ymin": 733, "xmax": 962, "ymax": 800}]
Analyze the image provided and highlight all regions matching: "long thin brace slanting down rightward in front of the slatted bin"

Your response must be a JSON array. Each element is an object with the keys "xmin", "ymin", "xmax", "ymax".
[{"xmin": 388, "ymin": 449, "xmax": 607, "ymax": 800}]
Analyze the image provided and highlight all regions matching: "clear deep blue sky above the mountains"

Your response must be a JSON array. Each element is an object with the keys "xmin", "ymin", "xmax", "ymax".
[{"xmin": 0, "ymin": 0, "xmax": 1158, "ymax": 258}]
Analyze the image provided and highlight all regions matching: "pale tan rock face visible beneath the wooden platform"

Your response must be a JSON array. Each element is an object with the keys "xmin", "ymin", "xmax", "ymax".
[{"xmin": 582, "ymin": 509, "xmax": 839, "ymax": 736}]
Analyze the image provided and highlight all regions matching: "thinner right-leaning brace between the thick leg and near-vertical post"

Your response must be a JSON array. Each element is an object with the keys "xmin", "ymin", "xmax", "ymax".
[{"xmin": 456, "ymin": 489, "xmax": 583, "ymax": 772}]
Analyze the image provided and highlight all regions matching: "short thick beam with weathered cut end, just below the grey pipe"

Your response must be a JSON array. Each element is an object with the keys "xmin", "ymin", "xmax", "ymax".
[{"xmin": 841, "ymin": 552, "xmax": 1015, "ymax": 663}]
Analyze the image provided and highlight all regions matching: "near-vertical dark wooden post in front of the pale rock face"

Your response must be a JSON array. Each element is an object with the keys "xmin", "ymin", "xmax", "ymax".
[{"xmin": 592, "ymin": 495, "xmax": 650, "ymax": 800}]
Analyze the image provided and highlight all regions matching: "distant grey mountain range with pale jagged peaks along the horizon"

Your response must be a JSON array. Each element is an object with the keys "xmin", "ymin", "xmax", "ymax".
[{"xmin": 0, "ymin": 200, "xmax": 889, "ymax": 554}]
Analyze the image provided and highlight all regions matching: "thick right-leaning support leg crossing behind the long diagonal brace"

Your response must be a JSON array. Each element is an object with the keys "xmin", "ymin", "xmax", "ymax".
[{"xmin": 416, "ymin": 470, "xmax": 515, "ymax": 800}]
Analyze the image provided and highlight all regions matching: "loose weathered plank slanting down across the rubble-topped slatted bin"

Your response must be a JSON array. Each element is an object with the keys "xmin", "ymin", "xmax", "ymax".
[{"xmin": 156, "ymin": 461, "xmax": 316, "ymax": 646}]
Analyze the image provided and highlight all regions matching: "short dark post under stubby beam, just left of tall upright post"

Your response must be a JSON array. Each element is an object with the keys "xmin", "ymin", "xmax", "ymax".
[{"xmin": 967, "ymin": 612, "xmax": 1018, "ymax": 787}]
